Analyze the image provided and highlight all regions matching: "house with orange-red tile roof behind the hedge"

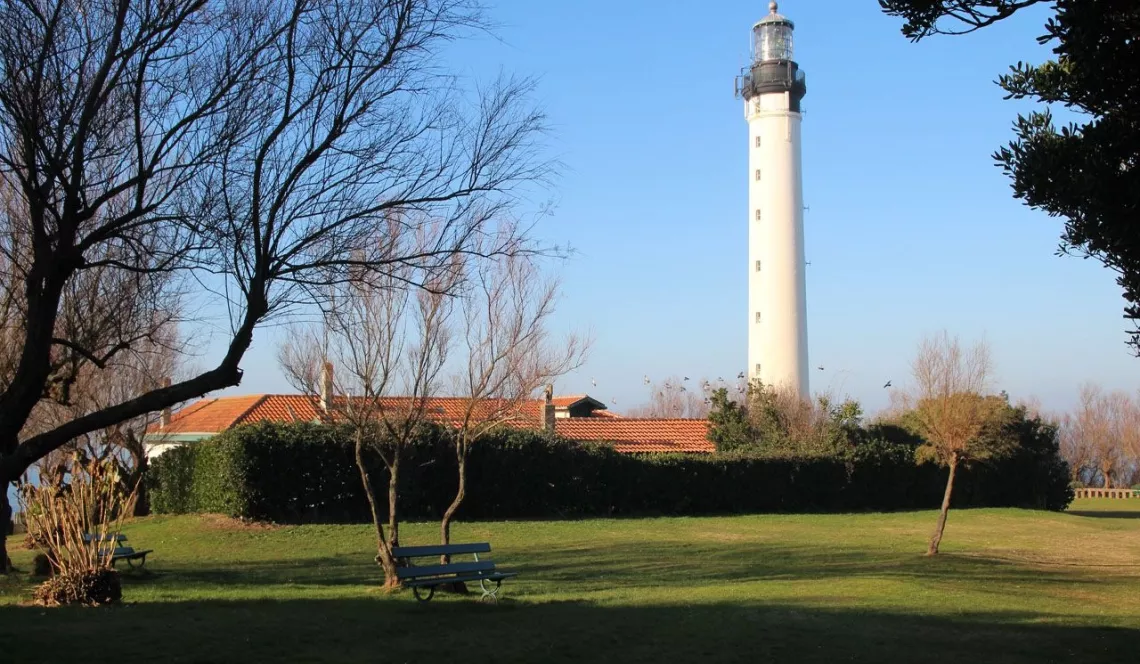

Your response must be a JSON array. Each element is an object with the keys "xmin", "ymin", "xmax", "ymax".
[{"xmin": 147, "ymin": 395, "xmax": 715, "ymax": 456}]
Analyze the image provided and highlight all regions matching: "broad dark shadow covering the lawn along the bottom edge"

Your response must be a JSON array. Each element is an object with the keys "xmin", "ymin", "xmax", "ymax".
[{"xmin": 0, "ymin": 592, "xmax": 1140, "ymax": 664}]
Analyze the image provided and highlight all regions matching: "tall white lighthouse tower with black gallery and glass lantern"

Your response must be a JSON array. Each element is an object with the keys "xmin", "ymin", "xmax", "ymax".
[{"xmin": 736, "ymin": 2, "xmax": 809, "ymax": 398}]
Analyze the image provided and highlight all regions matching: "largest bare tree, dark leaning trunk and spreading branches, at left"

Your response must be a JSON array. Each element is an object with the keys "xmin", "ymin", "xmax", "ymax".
[{"xmin": 0, "ymin": 0, "xmax": 551, "ymax": 572}]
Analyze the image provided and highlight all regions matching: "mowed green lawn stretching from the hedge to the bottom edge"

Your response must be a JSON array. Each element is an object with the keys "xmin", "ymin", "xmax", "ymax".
[{"xmin": 0, "ymin": 501, "xmax": 1140, "ymax": 664}]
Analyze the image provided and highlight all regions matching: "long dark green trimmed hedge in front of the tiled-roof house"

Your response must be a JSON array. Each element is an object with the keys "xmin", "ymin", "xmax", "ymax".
[{"xmin": 148, "ymin": 423, "xmax": 1072, "ymax": 523}]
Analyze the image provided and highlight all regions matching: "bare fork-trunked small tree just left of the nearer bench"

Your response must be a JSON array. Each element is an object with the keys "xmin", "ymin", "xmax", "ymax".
[{"xmin": 279, "ymin": 247, "xmax": 457, "ymax": 589}]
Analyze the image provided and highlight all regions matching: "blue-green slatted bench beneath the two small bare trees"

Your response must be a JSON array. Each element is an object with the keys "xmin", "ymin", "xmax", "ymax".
[{"xmin": 392, "ymin": 542, "xmax": 519, "ymax": 601}]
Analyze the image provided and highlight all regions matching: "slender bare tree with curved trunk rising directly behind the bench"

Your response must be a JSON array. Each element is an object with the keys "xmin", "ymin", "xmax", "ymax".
[{"xmin": 440, "ymin": 256, "xmax": 588, "ymax": 560}]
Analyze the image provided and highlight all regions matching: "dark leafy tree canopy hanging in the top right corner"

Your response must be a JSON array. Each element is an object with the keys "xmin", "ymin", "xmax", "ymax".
[{"xmin": 879, "ymin": 0, "xmax": 1140, "ymax": 353}]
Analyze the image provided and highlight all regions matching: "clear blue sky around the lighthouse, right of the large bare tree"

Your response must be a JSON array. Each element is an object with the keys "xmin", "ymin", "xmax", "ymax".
[{"xmin": 209, "ymin": 0, "xmax": 1140, "ymax": 412}]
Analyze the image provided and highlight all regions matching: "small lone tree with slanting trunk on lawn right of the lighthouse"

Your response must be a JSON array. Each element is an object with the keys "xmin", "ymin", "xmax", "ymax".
[{"xmin": 903, "ymin": 332, "xmax": 1010, "ymax": 556}]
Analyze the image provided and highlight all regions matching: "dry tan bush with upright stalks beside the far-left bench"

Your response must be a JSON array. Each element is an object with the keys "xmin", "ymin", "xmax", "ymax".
[{"xmin": 19, "ymin": 454, "xmax": 137, "ymax": 606}]
